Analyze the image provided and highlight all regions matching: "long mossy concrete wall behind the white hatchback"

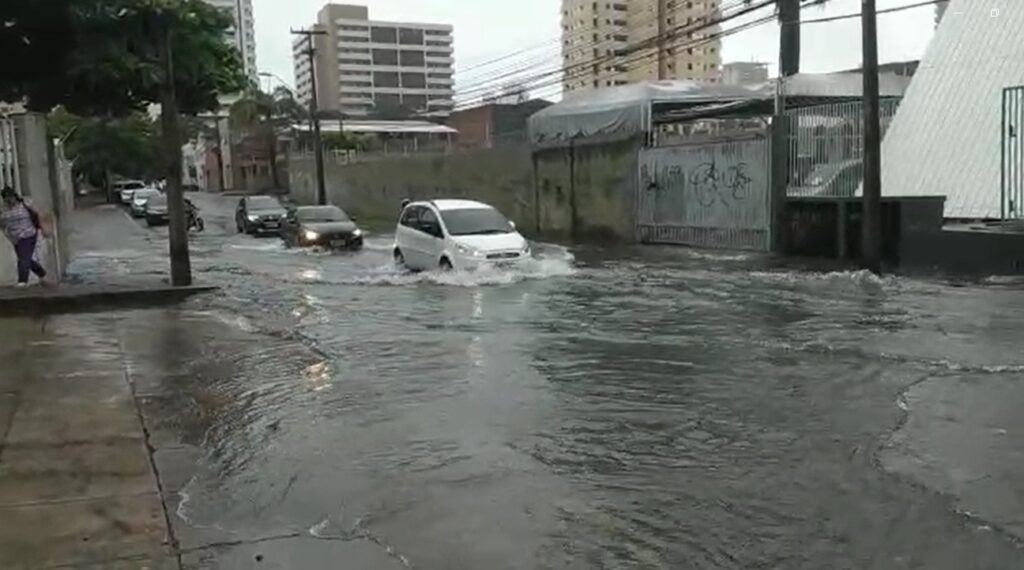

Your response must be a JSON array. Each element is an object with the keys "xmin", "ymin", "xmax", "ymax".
[{"xmin": 289, "ymin": 141, "xmax": 639, "ymax": 242}]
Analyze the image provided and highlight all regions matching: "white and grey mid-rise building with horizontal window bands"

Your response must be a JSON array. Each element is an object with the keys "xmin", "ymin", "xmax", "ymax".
[{"xmin": 292, "ymin": 4, "xmax": 455, "ymax": 119}]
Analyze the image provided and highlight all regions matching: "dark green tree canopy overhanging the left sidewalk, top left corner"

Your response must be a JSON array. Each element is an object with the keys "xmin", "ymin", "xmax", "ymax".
[{"xmin": 0, "ymin": 0, "xmax": 246, "ymax": 117}]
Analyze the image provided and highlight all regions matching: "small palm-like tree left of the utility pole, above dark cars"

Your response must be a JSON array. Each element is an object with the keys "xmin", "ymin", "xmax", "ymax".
[{"xmin": 230, "ymin": 87, "xmax": 309, "ymax": 188}]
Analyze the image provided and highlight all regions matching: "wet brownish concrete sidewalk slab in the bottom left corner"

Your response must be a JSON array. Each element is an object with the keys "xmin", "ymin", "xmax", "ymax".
[{"xmin": 0, "ymin": 317, "xmax": 178, "ymax": 570}]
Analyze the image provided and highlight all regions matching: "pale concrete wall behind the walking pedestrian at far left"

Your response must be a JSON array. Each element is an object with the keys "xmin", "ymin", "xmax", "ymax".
[{"xmin": 0, "ymin": 114, "xmax": 74, "ymax": 286}]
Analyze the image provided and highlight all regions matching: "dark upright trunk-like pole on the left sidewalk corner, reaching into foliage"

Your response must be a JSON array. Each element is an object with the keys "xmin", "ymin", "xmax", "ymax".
[{"xmin": 160, "ymin": 16, "xmax": 191, "ymax": 287}]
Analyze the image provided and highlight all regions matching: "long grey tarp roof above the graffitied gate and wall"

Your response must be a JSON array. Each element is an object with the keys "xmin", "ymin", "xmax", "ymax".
[{"xmin": 529, "ymin": 73, "xmax": 909, "ymax": 146}]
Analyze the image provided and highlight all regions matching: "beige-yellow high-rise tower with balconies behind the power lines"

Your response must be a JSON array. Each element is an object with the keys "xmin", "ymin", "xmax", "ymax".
[{"xmin": 562, "ymin": 0, "xmax": 722, "ymax": 93}]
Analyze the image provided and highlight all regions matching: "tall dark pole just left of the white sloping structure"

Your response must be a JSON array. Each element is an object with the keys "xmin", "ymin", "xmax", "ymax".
[{"xmin": 860, "ymin": 0, "xmax": 882, "ymax": 273}]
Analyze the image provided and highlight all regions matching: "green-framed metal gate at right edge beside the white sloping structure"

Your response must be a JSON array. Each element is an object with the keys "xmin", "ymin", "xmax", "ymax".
[{"xmin": 999, "ymin": 85, "xmax": 1024, "ymax": 220}]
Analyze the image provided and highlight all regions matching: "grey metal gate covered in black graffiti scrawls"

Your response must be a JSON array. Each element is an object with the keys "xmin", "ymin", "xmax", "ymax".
[{"xmin": 637, "ymin": 136, "xmax": 771, "ymax": 251}]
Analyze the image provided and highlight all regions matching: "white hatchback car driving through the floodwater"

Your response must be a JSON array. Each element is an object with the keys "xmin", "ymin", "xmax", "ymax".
[{"xmin": 394, "ymin": 200, "xmax": 531, "ymax": 270}]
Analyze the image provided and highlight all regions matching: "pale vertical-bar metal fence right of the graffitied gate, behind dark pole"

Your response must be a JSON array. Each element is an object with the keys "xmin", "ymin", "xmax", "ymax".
[{"xmin": 786, "ymin": 98, "xmax": 900, "ymax": 198}]
